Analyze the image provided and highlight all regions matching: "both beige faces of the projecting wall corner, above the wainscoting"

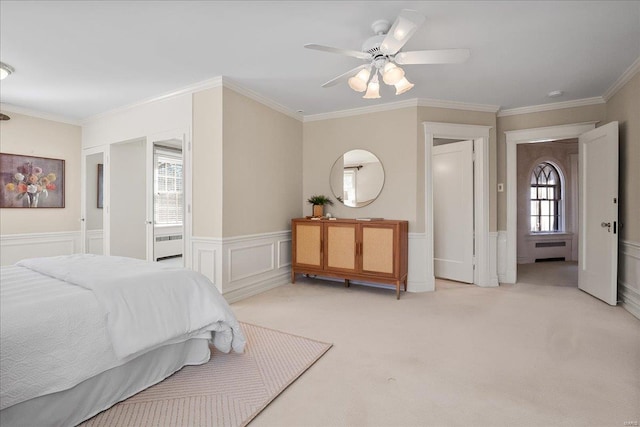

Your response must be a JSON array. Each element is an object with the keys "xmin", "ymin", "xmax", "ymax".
[{"xmin": 193, "ymin": 87, "xmax": 302, "ymax": 241}]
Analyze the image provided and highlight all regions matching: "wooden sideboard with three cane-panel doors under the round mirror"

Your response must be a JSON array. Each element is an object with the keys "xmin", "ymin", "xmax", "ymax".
[{"xmin": 291, "ymin": 218, "xmax": 409, "ymax": 299}]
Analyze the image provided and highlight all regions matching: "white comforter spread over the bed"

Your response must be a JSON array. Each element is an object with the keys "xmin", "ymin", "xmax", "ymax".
[{"xmin": 0, "ymin": 255, "xmax": 245, "ymax": 409}]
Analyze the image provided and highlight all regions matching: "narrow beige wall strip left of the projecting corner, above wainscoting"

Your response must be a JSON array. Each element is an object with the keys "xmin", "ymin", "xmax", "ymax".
[{"xmin": 191, "ymin": 87, "xmax": 224, "ymax": 237}]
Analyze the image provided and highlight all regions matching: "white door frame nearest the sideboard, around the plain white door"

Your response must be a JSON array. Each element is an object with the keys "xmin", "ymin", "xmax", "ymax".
[{"xmin": 422, "ymin": 122, "xmax": 498, "ymax": 289}]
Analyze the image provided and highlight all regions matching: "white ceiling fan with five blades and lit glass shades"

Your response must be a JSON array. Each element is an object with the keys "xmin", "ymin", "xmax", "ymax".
[{"xmin": 304, "ymin": 9, "xmax": 470, "ymax": 99}]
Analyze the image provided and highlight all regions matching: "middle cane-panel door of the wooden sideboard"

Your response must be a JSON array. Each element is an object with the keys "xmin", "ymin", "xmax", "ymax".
[{"xmin": 324, "ymin": 223, "xmax": 357, "ymax": 272}]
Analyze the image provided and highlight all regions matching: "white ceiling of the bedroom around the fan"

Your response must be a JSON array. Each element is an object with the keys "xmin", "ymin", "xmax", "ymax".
[{"xmin": 0, "ymin": 0, "xmax": 640, "ymax": 120}]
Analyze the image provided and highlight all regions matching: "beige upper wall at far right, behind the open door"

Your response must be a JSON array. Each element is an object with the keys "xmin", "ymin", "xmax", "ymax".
[{"xmin": 606, "ymin": 73, "xmax": 640, "ymax": 243}]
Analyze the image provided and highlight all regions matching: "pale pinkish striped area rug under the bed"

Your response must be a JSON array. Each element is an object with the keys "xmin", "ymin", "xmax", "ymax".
[{"xmin": 82, "ymin": 323, "xmax": 332, "ymax": 427}]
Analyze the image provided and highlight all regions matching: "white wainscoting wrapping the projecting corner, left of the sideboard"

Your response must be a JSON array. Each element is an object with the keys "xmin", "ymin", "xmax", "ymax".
[{"xmin": 191, "ymin": 230, "xmax": 291, "ymax": 302}]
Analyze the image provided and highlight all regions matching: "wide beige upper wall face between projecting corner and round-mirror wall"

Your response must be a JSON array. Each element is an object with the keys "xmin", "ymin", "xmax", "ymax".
[{"xmin": 222, "ymin": 88, "xmax": 302, "ymax": 237}]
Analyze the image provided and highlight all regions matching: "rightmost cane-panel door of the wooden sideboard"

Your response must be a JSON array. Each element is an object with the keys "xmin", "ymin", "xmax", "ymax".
[{"xmin": 360, "ymin": 224, "xmax": 398, "ymax": 278}]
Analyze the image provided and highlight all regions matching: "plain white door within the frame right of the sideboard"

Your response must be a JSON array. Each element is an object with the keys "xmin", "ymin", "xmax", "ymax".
[{"xmin": 432, "ymin": 141, "xmax": 473, "ymax": 283}]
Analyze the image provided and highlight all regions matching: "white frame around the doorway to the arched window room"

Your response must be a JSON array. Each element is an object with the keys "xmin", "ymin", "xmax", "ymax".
[{"xmin": 498, "ymin": 121, "xmax": 598, "ymax": 283}]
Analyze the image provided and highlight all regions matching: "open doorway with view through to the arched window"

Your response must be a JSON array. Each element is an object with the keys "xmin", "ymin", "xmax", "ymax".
[{"xmin": 514, "ymin": 138, "xmax": 579, "ymax": 288}]
